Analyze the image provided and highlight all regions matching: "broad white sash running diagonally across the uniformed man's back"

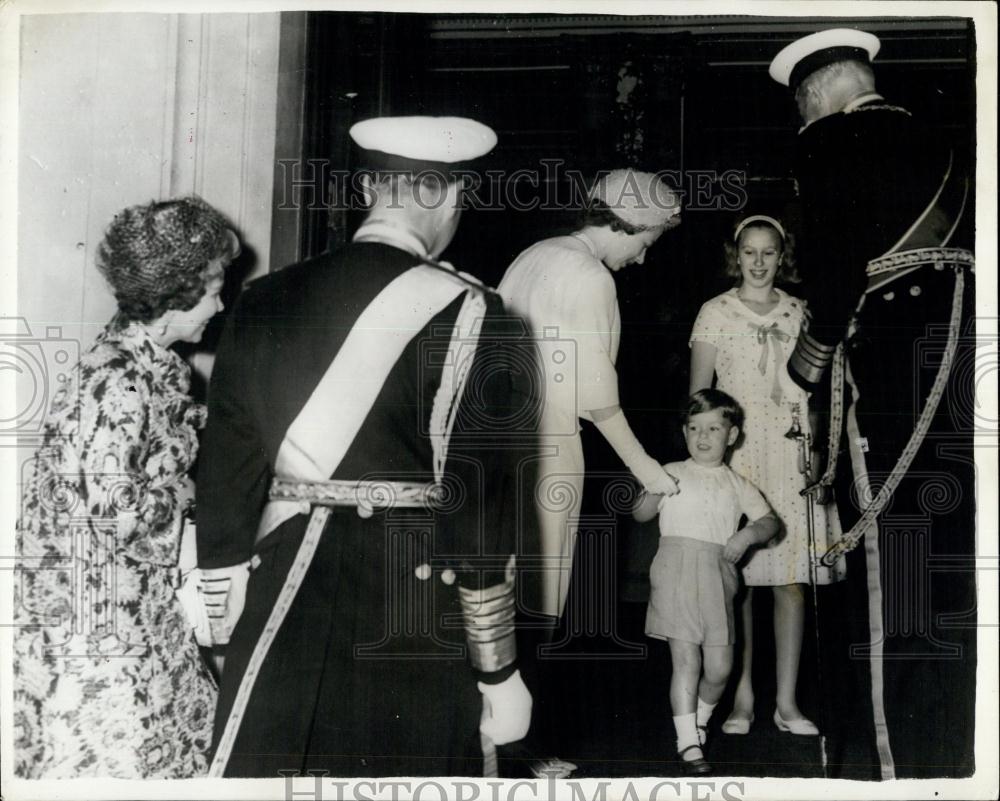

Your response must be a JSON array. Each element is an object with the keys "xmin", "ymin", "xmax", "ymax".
[{"xmin": 257, "ymin": 264, "xmax": 470, "ymax": 542}]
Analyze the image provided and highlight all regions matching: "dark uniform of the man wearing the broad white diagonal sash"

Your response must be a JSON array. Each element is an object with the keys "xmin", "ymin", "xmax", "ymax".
[{"xmin": 197, "ymin": 242, "xmax": 515, "ymax": 777}]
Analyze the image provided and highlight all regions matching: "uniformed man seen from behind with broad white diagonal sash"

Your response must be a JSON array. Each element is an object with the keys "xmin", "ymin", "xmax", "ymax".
[{"xmin": 198, "ymin": 117, "xmax": 531, "ymax": 777}]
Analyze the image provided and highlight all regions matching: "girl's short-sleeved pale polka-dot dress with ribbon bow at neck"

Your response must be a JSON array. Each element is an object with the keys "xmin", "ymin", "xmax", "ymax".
[{"xmin": 691, "ymin": 288, "xmax": 846, "ymax": 587}]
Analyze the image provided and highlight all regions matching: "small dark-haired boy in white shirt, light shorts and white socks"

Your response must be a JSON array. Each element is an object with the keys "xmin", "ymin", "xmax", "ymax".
[{"xmin": 634, "ymin": 389, "xmax": 780, "ymax": 775}]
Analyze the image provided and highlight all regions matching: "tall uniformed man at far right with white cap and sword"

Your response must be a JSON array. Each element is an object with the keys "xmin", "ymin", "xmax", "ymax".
[{"xmin": 770, "ymin": 29, "xmax": 976, "ymax": 779}]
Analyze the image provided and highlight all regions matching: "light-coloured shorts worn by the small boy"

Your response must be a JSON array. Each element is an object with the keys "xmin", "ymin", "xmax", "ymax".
[{"xmin": 646, "ymin": 536, "xmax": 739, "ymax": 646}]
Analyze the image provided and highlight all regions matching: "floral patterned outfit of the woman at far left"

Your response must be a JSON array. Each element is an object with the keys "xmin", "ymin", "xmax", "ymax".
[{"xmin": 14, "ymin": 323, "xmax": 217, "ymax": 779}]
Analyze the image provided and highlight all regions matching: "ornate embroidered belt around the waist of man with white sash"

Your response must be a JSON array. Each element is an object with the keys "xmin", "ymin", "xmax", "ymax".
[{"xmin": 268, "ymin": 478, "xmax": 444, "ymax": 516}]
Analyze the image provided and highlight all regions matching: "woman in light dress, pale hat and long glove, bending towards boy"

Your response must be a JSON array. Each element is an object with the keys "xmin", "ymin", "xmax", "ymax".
[{"xmin": 497, "ymin": 169, "xmax": 680, "ymax": 620}]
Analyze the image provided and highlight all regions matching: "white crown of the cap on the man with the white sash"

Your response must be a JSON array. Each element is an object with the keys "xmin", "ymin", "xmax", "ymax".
[{"xmin": 350, "ymin": 117, "xmax": 497, "ymax": 164}]
